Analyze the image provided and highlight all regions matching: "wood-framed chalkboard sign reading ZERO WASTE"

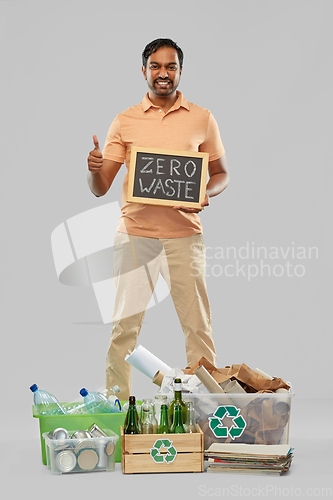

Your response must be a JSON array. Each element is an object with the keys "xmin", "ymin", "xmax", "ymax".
[{"xmin": 127, "ymin": 146, "xmax": 209, "ymax": 208}]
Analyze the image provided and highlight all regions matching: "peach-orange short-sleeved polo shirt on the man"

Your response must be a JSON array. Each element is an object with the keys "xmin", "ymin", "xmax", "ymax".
[{"xmin": 103, "ymin": 91, "xmax": 225, "ymax": 238}]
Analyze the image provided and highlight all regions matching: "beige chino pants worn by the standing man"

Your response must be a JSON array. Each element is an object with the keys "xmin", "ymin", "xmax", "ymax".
[{"xmin": 106, "ymin": 233, "xmax": 216, "ymax": 400}]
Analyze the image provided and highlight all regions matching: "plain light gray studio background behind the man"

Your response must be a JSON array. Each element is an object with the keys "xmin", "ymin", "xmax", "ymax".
[{"xmin": 0, "ymin": 0, "xmax": 333, "ymax": 498}]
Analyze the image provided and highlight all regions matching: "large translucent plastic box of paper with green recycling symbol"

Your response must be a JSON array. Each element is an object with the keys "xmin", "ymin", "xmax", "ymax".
[{"xmin": 183, "ymin": 390, "xmax": 294, "ymax": 449}]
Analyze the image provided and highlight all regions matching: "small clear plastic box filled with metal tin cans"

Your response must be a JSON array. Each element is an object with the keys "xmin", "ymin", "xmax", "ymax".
[{"xmin": 43, "ymin": 429, "xmax": 119, "ymax": 474}]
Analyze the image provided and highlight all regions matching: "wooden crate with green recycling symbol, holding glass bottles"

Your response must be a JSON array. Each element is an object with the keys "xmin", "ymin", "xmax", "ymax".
[{"xmin": 120, "ymin": 426, "xmax": 204, "ymax": 474}]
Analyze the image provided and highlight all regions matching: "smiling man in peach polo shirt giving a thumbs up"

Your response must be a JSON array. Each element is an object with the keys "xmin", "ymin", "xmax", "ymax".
[{"xmin": 88, "ymin": 38, "xmax": 229, "ymax": 399}]
